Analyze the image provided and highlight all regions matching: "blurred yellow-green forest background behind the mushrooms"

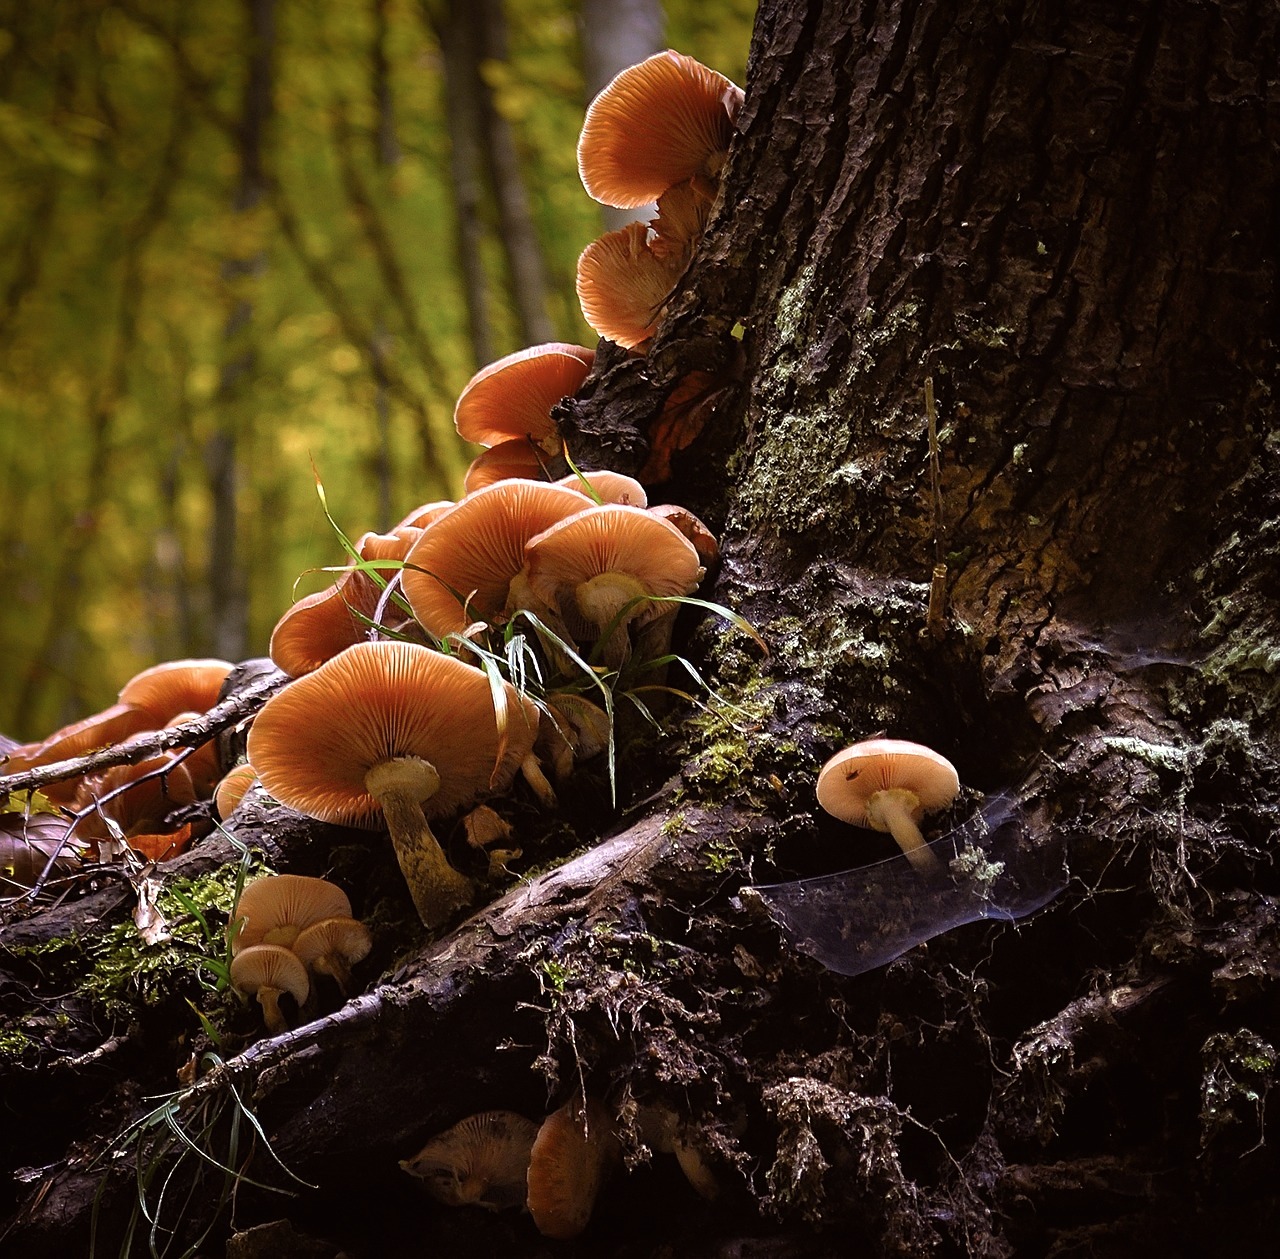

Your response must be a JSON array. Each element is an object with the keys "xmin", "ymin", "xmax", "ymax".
[{"xmin": 0, "ymin": 0, "xmax": 755, "ymax": 740}]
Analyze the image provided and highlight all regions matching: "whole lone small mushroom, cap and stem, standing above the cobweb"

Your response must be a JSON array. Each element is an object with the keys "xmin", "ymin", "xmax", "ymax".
[{"xmin": 818, "ymin": 738, "xmax": 960, "ymax": 874}]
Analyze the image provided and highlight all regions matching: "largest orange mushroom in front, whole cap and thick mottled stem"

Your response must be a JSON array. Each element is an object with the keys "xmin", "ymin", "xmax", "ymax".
[{"xmin": 248, "ymin": 642, "xmax": 538, "ymax": 926}]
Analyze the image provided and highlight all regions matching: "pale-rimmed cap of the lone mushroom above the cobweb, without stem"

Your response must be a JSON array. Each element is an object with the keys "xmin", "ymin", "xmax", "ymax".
[{"xmin": 818, "ymin": 738, "xmax": 960, "ymax": 827}]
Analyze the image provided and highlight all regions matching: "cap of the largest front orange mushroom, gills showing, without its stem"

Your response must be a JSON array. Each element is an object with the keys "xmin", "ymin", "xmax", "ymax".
[{"xmin": 248, "ymin": 642, "xmax": 538, "ymax": 827}]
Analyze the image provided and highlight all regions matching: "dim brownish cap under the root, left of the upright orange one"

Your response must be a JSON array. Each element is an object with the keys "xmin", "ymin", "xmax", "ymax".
[{"xmin": 401, "ymin": 1111, "xmax": 538, "ymax": 1210}]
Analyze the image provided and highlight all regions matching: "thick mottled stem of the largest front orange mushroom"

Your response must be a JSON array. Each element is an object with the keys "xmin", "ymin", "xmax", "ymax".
[{"xmin": 365, "ymin": 756, "xmax": 475, "ymax": 928}]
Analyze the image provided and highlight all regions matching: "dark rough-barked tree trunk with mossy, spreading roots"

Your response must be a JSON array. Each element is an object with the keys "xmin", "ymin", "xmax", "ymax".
[{"xmin": 2, "ymin": 0, "xmax": 1280, "ymax": 1256}]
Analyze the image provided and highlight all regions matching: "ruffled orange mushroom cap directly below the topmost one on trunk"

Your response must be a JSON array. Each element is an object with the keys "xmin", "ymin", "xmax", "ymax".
[{"xmin": 575, "ymin": 223, "xmax": 685, "ymax": 349}]
